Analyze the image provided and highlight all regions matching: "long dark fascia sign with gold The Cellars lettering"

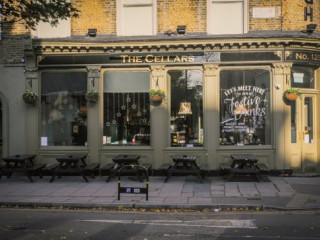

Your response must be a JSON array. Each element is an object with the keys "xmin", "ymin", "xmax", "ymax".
[{"xmin": 38, "ymin": 51, "xmax": 282, "ymax": 66}]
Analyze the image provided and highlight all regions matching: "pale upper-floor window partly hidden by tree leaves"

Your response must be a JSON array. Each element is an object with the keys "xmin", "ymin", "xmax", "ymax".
[{"xmin": 32, "ymin": 18, "xmax": 71, "ymax": 38}]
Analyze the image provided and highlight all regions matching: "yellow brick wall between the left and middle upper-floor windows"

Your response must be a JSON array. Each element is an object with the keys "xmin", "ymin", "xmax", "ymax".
[{"xmin": 71, "ymin": 0, "xmax": 116, "ymax": 35}]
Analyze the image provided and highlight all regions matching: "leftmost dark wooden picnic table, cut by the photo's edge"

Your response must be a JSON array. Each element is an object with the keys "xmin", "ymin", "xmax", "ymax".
[{"xmin": 0, "ymin": 154, "xmax": 45, "ymax": 182}]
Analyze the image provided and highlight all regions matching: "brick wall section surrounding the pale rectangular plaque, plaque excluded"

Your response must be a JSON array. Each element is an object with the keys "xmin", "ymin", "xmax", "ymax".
[{"xmin": 249, "ymin": 0, "xmax": 281, "ymax": 31}]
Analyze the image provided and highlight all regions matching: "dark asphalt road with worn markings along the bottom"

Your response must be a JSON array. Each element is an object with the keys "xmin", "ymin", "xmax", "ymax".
[{"xmin": 0, "ymin": 209, "xmax": 320, "ymax": 240}]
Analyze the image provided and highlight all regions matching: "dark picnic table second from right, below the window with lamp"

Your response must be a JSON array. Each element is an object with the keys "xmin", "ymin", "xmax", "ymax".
[{"xmin": 159, "ymin": 154, "xmax": 203, "ymax": 183}]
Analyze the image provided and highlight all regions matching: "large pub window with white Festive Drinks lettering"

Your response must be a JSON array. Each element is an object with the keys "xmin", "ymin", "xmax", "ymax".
[{"xmin": 220, "ymin": 69, "xmax": 271, "ymax": 146}]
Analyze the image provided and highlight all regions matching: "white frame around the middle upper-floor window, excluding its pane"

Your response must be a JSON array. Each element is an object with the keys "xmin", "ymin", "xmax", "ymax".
[{"xmin": 116, "ymin": 0, "xmax": 157, "ymax": 36}]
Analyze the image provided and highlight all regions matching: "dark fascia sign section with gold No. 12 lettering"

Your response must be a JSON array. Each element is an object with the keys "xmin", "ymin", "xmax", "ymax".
[{"xmin": 285, "ymin": 51, "xmax": 320, "ymax": 64}]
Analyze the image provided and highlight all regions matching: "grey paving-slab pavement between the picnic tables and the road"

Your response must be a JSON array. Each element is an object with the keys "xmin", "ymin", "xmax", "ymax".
[{"xmin": 0, "ymin": 175, "xmax": 320, "ymax": 211}]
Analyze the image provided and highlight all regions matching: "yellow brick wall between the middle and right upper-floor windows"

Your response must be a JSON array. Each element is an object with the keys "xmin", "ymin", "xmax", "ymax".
[{"xmin": 158, "ymin": 0, "xmax": 207, "ymax": 33}]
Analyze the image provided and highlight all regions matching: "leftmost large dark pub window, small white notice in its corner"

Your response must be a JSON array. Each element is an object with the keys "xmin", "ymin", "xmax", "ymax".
[{"xmin": 41, "ymin": 72, "xmax": 87, "ymax": 146}]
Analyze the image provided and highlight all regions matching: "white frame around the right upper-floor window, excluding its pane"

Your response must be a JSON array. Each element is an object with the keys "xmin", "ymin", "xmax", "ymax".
[{"xmin": 207, "ymin": 0, "xmax": 249, "ymax": 34}]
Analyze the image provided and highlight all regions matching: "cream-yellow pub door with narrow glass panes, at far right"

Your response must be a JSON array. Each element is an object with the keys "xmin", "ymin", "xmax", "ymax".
[{"xmin": 290, "ymin": 94, "xmax": 319, "ymax": 172}]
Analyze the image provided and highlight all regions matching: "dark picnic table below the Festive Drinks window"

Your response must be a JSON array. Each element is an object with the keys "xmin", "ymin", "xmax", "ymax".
[{"xmin": 219, "ymin": 154, "xmax": 269, "ymax": 181}]
